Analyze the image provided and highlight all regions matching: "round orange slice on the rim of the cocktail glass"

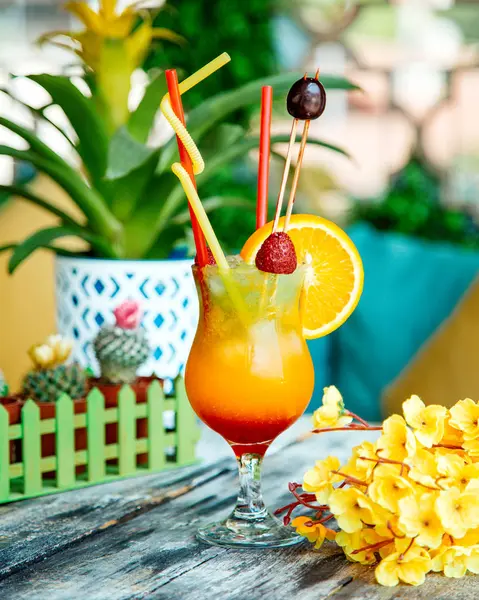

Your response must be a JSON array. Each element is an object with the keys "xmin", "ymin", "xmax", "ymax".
[{"xmin": 241, "ymin": 215, "xmax": 364, "ymax": 339}]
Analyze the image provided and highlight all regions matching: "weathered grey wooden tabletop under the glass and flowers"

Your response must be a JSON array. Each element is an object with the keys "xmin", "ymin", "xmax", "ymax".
[{"xmin": 0, "ymin": 420, "xmax": 479, "ymax": 600}]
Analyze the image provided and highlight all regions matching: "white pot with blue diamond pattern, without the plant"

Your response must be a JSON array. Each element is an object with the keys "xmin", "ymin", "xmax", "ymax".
[{"xmin": 55, "ymin": 256, "xmax": 198, "ymax": 378}]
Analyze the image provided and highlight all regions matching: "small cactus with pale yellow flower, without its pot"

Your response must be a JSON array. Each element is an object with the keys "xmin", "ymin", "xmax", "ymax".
[{"xmin": 22, "ymin": 335, "xmax": 87, "ymax": 402}]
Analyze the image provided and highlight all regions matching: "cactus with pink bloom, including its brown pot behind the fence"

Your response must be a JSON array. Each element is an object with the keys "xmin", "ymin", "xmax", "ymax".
[{"xmin": 90, "ymin": 300, "xmax": 155, "ymax": 464}]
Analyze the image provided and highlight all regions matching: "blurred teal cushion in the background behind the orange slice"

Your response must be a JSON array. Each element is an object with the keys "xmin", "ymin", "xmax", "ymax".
[{"xmin": 328, "ymin": 223, "xmax": 479, "ymax": 421}]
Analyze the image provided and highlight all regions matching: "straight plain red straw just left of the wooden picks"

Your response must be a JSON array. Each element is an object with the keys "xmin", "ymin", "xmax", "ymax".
[{"xmin": 256, "ymin": 85, "xmax": 273, "ymax": 229}]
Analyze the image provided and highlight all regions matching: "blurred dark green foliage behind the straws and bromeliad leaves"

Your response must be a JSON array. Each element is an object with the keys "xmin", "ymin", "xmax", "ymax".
[{"xmin": 145, "ymin": 0, "xmax": 278, "ymax": 253}]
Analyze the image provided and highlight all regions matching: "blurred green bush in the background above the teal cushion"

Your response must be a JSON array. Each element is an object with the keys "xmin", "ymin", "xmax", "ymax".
[{"xmin": 353, "ymin": 157, "xmax": 479, "ymax": 249}]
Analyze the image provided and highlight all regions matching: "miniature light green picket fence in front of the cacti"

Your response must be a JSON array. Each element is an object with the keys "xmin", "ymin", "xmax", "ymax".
[{"xmin": 0, "ymin": 378, "xmax": 199, "ymax": 504}]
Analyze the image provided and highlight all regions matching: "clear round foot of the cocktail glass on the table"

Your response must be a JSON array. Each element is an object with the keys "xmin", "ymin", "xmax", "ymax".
[{"xmin": 197, "ymin": 512, "xmax": 304, "ymax": 548}]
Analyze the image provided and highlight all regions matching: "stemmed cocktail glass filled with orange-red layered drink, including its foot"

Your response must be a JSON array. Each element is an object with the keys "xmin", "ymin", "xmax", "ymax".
[{"xmin": 186, "ymin": 264, "xmax": 314, "ymax": 547}]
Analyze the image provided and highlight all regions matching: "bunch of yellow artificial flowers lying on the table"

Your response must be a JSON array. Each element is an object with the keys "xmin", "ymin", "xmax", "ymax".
[{"xmin": 276, "ymin": 387, "xmax": 479, "ymax": 586}]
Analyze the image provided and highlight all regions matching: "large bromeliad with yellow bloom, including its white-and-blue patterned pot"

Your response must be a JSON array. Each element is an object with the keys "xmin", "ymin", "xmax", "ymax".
[{"xmin": 0, "ymin": 0, "xmax": 354, "ymax": 377}]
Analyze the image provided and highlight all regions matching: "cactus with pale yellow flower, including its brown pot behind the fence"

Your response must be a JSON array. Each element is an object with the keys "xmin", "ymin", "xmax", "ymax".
[{"xmin": 22, "ymin": 335, "xmax": 88, "ymax": 466}]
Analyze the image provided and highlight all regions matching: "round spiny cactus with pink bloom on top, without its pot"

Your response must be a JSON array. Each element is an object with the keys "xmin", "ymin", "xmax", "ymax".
[{"xmin": 93, "ymin": 301, "xmax": 150, "ymax": 383}]
